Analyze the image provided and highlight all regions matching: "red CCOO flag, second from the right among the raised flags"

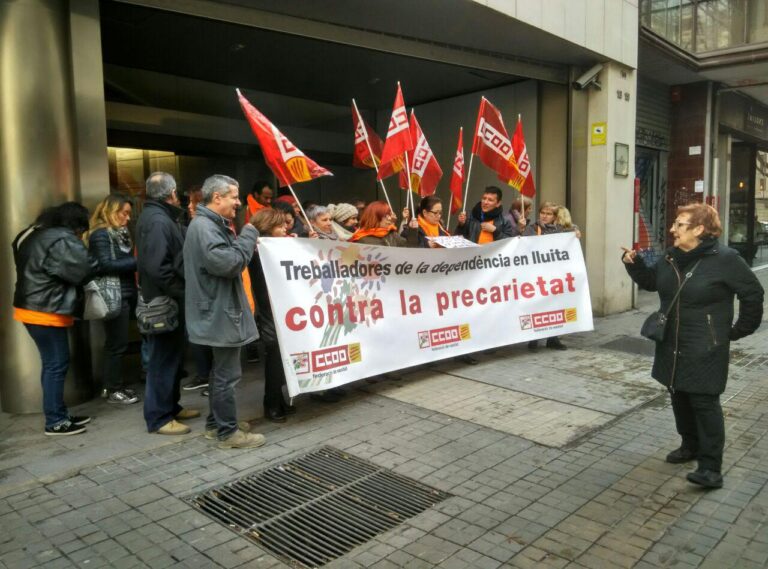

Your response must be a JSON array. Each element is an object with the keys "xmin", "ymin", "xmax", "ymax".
[{"xmin": 472, "ymin": 97, "xmax": 523, "ymax": 189}]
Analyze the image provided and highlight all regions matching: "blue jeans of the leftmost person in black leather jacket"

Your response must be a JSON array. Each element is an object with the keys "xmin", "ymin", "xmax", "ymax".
[{"xmin": 24, "ymin": 324, "xmax": 69, "ymax": 428}]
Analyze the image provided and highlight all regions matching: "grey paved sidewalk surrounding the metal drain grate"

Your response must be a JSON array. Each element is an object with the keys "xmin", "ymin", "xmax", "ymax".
[{"xmin": 0, "ymin": 271, "xmax": 768, "ymax": 569}]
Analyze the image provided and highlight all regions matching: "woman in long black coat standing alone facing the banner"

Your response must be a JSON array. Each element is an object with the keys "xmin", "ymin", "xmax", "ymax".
[{"xmin": 622, "ymin": 204, "xmax": 764, "ymax": 488}]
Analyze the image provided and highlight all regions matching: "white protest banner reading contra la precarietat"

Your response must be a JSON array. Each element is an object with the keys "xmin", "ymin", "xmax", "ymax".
[{"xmin": 259, "ymin": 233, "xmax": 592, "ymax": 397}]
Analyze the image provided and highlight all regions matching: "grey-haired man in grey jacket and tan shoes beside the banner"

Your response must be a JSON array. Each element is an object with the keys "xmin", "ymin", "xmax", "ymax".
[{"xmin": 184, "ymin": 174, "xmax": 264, "ymax": 448}]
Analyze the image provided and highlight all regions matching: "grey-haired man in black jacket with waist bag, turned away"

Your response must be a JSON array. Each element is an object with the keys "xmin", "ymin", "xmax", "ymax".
[{"xmin": 136, "ymin": 172, "xmax": 200, "ymax": 435}]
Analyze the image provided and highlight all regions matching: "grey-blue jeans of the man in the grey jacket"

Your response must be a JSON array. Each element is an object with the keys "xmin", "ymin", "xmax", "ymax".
[{"xmin": 205, "ymin": 347, "xmax": 242, "ymax": 440}]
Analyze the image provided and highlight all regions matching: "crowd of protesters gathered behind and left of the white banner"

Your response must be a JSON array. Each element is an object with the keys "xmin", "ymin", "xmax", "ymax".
[{"xmin": 13, "ymin": 172, "xmax": 578, "ymax": 448}]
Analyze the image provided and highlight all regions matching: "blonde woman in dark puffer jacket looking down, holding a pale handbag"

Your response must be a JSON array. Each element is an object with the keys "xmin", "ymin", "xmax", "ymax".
[{"xmin": 87, "ymin": 194, "xmax": 139, "ymax": 405}]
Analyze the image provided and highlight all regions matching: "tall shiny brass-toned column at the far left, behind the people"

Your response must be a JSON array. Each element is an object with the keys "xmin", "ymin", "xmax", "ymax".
[{"xmin": 0, "ymin": 0, "xmax": 109, "ymax": 413}]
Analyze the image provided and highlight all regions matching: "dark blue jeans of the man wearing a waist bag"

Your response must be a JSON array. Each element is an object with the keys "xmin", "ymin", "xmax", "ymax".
[{"xmin": 144, "ymin": 321, "xmax": 184, "ymax": 433}]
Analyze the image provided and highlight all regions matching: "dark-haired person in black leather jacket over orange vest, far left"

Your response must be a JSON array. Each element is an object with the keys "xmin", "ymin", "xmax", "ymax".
[{"xmin": 12, "ymin": 202, "xmax": 96, "ymax": 436}]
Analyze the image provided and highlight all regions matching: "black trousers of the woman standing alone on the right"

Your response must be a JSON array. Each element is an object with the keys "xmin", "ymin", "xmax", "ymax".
[{"xmin": 672, "ymin": 391, "xmax": 725, "ymax": 472}]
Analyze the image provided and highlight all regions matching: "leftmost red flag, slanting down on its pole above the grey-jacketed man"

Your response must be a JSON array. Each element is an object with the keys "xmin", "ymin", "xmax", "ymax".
[{"xmin": 237, "ymin": 89, "xmax": 333, "ymax": 186}]
